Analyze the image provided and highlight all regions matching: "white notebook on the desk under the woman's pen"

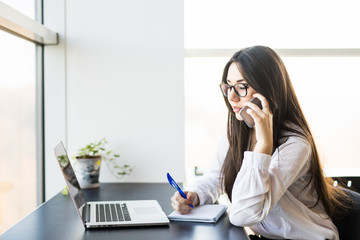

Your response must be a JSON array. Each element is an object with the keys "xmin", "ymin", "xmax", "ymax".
[{"xmin": 168, "ymin": 204, "xmax": 227, "ymax": 223}]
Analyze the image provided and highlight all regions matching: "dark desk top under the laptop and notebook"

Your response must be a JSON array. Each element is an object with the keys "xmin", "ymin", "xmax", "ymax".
[{"xmin": 0, "ymin": 183, "xmax": 247, "ymax": 240}]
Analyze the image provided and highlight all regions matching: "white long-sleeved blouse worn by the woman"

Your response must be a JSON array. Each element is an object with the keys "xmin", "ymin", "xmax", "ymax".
[{"xmin": 188, "ymin": 128, "xmax": 339, "ymax": 240}]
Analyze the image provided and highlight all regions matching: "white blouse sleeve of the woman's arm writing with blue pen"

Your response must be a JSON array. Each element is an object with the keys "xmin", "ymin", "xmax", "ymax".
[{"xmin": 187, "ymin": 131, "xmax": 229, "ymax": 205}]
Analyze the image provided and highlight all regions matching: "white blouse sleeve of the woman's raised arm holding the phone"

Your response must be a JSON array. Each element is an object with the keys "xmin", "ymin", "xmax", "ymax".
[{"xmin": 229, "ymin": 137, "xmax": 311, "ymax": 226}]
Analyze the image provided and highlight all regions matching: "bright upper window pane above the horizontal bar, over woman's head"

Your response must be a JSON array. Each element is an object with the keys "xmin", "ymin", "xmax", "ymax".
[{"xmin": 184, "ymin": 0, "xmax": 360, "ymax": 49}]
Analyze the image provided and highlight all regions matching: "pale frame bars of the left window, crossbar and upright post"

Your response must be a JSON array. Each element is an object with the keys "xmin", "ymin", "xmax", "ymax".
[{"xmin": 0, "ymin": 0, "xmax": 59, "ymax": 205}]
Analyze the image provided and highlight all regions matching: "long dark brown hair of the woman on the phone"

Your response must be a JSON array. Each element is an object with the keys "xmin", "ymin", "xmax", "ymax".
[{"xmin": 221, "ymin": 46, "xmax": 346, "ymax": 217}]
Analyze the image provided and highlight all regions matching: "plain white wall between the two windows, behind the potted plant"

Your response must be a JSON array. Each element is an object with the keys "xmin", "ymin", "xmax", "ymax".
[{"xmin": 44, "ymin": 0, "xmax": 185, "ymax": 198}]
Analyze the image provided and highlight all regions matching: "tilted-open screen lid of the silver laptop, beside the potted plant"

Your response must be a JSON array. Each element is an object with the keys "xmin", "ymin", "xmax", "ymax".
[{"xmin": 54, "ymin": 142, "xmax": 86, "ymax": 219}]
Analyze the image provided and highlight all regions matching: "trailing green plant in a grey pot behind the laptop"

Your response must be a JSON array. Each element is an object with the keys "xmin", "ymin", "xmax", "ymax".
[{"xmin": 74, "ymin": 138, "xmax": 133, "ymax": 188}]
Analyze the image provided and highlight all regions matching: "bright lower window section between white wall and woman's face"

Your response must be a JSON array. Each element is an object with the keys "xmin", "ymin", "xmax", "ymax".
[{"xmin": 184, "ymin": 58, "xmax": 228, "ymax": 181}]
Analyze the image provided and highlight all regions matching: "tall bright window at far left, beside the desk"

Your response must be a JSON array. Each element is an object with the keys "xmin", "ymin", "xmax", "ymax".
[{"xmin": 0, "ymin": 0, "xmax": 51, "ymax": 234}]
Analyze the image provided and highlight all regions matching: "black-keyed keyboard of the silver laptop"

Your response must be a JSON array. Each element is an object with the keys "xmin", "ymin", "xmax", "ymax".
[{"xmin": 96, "ymin": 203, "xmax": 131, "ymax": 222}]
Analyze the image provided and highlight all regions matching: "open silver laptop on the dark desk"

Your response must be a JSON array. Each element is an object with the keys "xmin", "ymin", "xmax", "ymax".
[{"xmin": 54, "ymin": 142, "xmax": 169, "ymax": 228}]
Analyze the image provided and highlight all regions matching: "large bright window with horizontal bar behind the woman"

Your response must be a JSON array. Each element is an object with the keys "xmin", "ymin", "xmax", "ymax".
[{"xmin": 185, "ymin": 0, "xmax": 360, "ymax": 182}]
